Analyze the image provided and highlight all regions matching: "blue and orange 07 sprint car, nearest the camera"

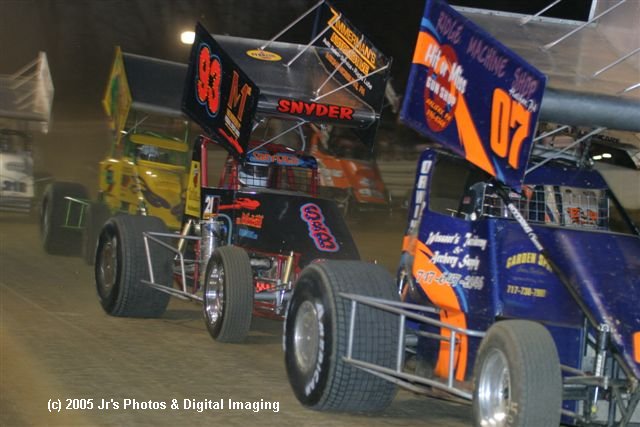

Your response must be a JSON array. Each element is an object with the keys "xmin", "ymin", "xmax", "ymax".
[{"xmin": 284, "ymin": 1, "xmax": 640, "ymax": 426}]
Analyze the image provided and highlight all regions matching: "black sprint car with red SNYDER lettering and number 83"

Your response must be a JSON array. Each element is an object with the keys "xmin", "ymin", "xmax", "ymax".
[{"xmin": 95, "ymin": 4, "xmax": 389, "ymax": 342}]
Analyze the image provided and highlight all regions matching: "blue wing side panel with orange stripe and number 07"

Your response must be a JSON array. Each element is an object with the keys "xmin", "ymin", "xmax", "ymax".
[{"xmin": 401, "ymin": 0, "xmax": 546, "ymax": 187}]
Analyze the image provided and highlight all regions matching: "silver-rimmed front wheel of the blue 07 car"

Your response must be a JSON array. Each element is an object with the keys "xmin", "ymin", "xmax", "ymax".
[{"xmin": 473, "ymin": 320, "xmax": 562, "ymax": 427}]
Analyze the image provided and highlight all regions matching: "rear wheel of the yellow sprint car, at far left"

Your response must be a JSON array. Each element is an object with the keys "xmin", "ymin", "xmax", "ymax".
[{"xmin": 40, "ymin": 182, "xmax": 89, "ymax": 255}]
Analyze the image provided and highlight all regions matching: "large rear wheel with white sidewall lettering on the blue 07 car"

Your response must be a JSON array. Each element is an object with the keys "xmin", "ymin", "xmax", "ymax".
[{"xmin": 284, "ymin": 261, "xmax": 399, "ymax": 412}]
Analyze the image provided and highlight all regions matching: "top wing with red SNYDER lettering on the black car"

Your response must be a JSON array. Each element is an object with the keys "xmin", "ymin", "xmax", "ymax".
[{"xmin": 183, "ymin": 1, "xmax": 391, "ymax": 159}]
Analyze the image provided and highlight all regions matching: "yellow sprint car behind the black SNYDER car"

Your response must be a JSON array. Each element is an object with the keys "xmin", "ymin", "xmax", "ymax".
[{"xmin": 40, "ymin": 47, "xmax": 195, "ymax": 264}]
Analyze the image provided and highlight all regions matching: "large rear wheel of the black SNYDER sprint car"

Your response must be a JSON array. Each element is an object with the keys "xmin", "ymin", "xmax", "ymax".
[{"xmin": 94, "ymin": 215, "xmax": 172, "ymax": 317}]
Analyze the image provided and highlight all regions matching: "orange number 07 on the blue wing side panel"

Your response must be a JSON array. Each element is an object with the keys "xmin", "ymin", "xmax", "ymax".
[{"xmin": 490, "ymin": 88, "xmax": 531, "ymax": 169}]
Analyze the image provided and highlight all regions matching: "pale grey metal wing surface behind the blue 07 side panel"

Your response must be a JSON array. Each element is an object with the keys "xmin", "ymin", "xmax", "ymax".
[{"xmin": 457, "ymin": 0, "xmax": 640, "ymax": 100}]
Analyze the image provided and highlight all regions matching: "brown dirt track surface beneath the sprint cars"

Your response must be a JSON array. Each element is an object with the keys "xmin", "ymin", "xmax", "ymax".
[{"xmin": 0, "ymin": 213, "xmax": 470, "ymax": 426}]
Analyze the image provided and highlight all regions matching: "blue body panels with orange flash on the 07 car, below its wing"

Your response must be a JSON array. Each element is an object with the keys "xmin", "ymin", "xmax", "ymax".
[{"xmin": 404, "ymin": 150, "xmax": 640, "ymax": 380}]
